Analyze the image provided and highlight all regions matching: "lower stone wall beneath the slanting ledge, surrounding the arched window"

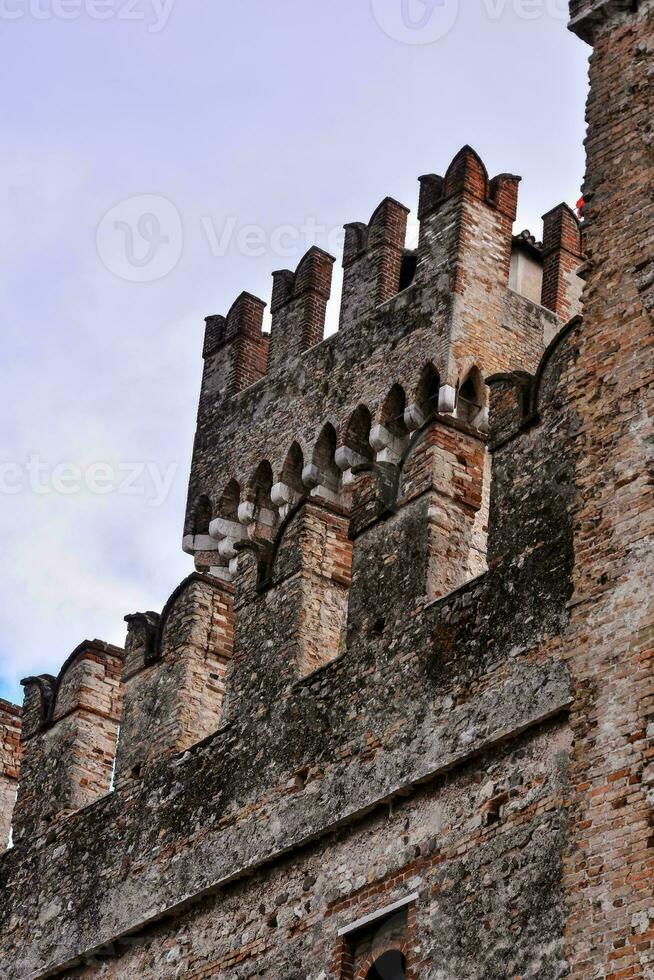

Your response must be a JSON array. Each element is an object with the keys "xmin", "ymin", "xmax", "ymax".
[{"xmin": 61, "ymin": 722, "xmax": 569, "ymax": 980}]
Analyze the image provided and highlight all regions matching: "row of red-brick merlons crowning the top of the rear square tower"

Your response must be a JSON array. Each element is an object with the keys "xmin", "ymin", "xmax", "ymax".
[{"xmin": 193, "ymin": 146, "xmax": 579, "ymax": 406}]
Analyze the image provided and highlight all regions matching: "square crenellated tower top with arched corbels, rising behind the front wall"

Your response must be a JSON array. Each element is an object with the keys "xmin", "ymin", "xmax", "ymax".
[{"xmin": 183, "ymin": 146, "xmax": 582, "ymax": 581}]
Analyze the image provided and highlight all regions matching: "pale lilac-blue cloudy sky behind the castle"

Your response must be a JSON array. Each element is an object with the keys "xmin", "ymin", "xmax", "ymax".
[{"xmin": 0, "ymin": 0, "xmax": 588, "ymax": 700}]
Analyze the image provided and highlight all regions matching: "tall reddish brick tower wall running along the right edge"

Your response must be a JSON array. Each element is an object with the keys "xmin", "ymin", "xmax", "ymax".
[{"xmin": 566, "ymin": 2, "xmax": 654, "ymax": 977}]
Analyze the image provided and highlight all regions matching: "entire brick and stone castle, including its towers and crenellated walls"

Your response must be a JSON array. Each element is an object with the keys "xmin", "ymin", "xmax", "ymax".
[{"xmin": 0, "ymin": 0, "xmax": 654, "ymax": 980}]
